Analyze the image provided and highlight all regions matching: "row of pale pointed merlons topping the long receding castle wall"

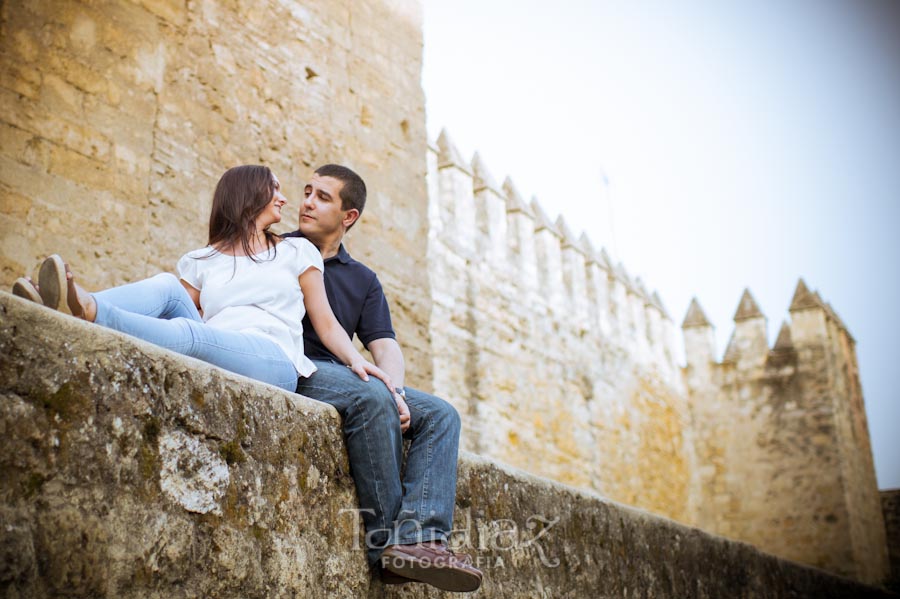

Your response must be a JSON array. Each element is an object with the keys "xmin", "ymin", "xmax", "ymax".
[{"xmin": 428, "ymin": 130, "xmax": 678, "ymax": 377}]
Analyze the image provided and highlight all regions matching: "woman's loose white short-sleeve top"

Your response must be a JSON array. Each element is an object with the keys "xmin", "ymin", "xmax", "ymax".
[{"xmin": 178, "ymin": 237, "xmax": 323, "ymax": 376}]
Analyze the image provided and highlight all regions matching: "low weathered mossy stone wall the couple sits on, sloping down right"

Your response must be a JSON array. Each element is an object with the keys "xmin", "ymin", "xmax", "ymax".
[{"xmin": 0, "ymin": 293, "xmax": 888, "ymax": 599}]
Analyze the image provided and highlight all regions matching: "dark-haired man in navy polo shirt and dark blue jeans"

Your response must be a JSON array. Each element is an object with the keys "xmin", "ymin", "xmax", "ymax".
[{"xmin": 286, "ymin": 164, "xmax": 482, "ymax": 591}]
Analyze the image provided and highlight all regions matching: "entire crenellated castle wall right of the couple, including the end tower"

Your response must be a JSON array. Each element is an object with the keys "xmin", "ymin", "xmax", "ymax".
[{"xmin": 427, "ymin": 131, "xmax": 884, "ymax": 580}]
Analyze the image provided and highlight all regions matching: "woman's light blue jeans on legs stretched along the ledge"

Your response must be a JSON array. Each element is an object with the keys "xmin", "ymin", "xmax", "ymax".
[{"xmin": 93, "ymin": 273, "xmax": 298, "ymax": 391}]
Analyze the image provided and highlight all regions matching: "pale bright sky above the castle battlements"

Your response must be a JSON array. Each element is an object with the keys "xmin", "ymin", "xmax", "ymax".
[{"xmin": 422, "ymin": 0, "xmax": 900, "ymax": 489}]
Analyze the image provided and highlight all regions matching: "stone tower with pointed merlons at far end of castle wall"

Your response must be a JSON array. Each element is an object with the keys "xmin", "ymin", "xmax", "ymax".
[{"xmin": 684, "ymin": 281, "xmax": 888, "ymax": 581}]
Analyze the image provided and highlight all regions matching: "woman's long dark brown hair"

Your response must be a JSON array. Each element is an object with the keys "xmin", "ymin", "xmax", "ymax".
[{"xmin": 208, "ymin": 164, "xmax": 277, "ymax": 262}]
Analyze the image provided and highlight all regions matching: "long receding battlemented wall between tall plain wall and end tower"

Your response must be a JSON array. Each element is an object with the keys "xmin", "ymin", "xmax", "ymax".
[{"xmin": 428, "ymin": 135, "xmax": 692, "ymax": 521}]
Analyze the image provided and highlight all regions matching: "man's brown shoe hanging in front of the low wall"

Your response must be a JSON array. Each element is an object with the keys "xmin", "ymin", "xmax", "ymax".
[{"xmin": 381, "ymin": 543, "xmax": 482, "ymax": 593}]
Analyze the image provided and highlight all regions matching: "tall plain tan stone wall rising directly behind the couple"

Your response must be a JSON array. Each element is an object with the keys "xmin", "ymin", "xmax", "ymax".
[{"xmin": 0, "ymin": 0, "xmax": 431, "ymax": 388}]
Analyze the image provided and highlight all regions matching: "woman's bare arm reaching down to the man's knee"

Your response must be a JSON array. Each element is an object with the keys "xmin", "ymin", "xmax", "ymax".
[{"xmin": 300, "ymin": 268, "xmax": 394, "ymax": 393}]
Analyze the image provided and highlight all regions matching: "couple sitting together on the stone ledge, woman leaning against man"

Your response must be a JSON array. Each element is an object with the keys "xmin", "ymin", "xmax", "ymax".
[{"xmin": 13, "ymin": 165, "xmax": 482, "ymax": 591}]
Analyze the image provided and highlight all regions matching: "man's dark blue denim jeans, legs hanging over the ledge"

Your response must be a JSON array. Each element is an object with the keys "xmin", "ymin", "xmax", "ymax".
[{"xmin": 297, "ymin": 360, "xmax": 460, "ymax": 564}]
